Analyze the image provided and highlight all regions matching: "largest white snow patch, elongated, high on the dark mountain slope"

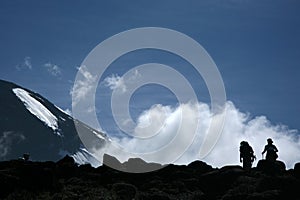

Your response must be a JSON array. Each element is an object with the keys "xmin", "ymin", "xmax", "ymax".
[{"xmin": 13, "ymin": 88, "xmax": 61, "ymax": 136}]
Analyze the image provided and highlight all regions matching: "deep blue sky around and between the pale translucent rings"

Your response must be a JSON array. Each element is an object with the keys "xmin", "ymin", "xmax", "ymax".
[{"xmin": 0, "ymin": 0, "xmax": 300, "ymax": 142}]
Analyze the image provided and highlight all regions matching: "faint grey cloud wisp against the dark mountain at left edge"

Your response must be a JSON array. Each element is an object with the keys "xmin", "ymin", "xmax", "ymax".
[{"xmin": 0, "ymin": 131, "xmax": 25, "ymax": 159}]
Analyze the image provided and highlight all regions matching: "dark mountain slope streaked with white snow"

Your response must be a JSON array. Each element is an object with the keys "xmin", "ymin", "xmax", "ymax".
[{"xmin": 0, "ymin": 80, "xmax": 108, "ymax": 166}]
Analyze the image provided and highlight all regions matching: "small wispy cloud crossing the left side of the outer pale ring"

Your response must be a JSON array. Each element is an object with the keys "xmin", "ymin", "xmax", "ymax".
[{"xmin": 70, "ymin": 66, "xmax": 97, "ymax": 105}]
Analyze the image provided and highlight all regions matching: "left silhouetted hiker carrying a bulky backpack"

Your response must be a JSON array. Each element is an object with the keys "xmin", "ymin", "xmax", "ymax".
[{"xmin": 240, "ymin": 141, "xmax": 256, "ymax": 170}]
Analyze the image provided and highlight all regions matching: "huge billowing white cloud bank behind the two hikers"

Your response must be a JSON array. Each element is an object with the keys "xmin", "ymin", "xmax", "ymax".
[{"xmin": 107, "ymin": 101, "xmax": 300, "ymax": 168}]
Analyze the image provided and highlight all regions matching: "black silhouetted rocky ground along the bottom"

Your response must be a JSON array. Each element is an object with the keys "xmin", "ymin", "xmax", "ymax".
[{"xmin": 0, "ymin": 155, "xmax": 300, "ymax": 200}]
